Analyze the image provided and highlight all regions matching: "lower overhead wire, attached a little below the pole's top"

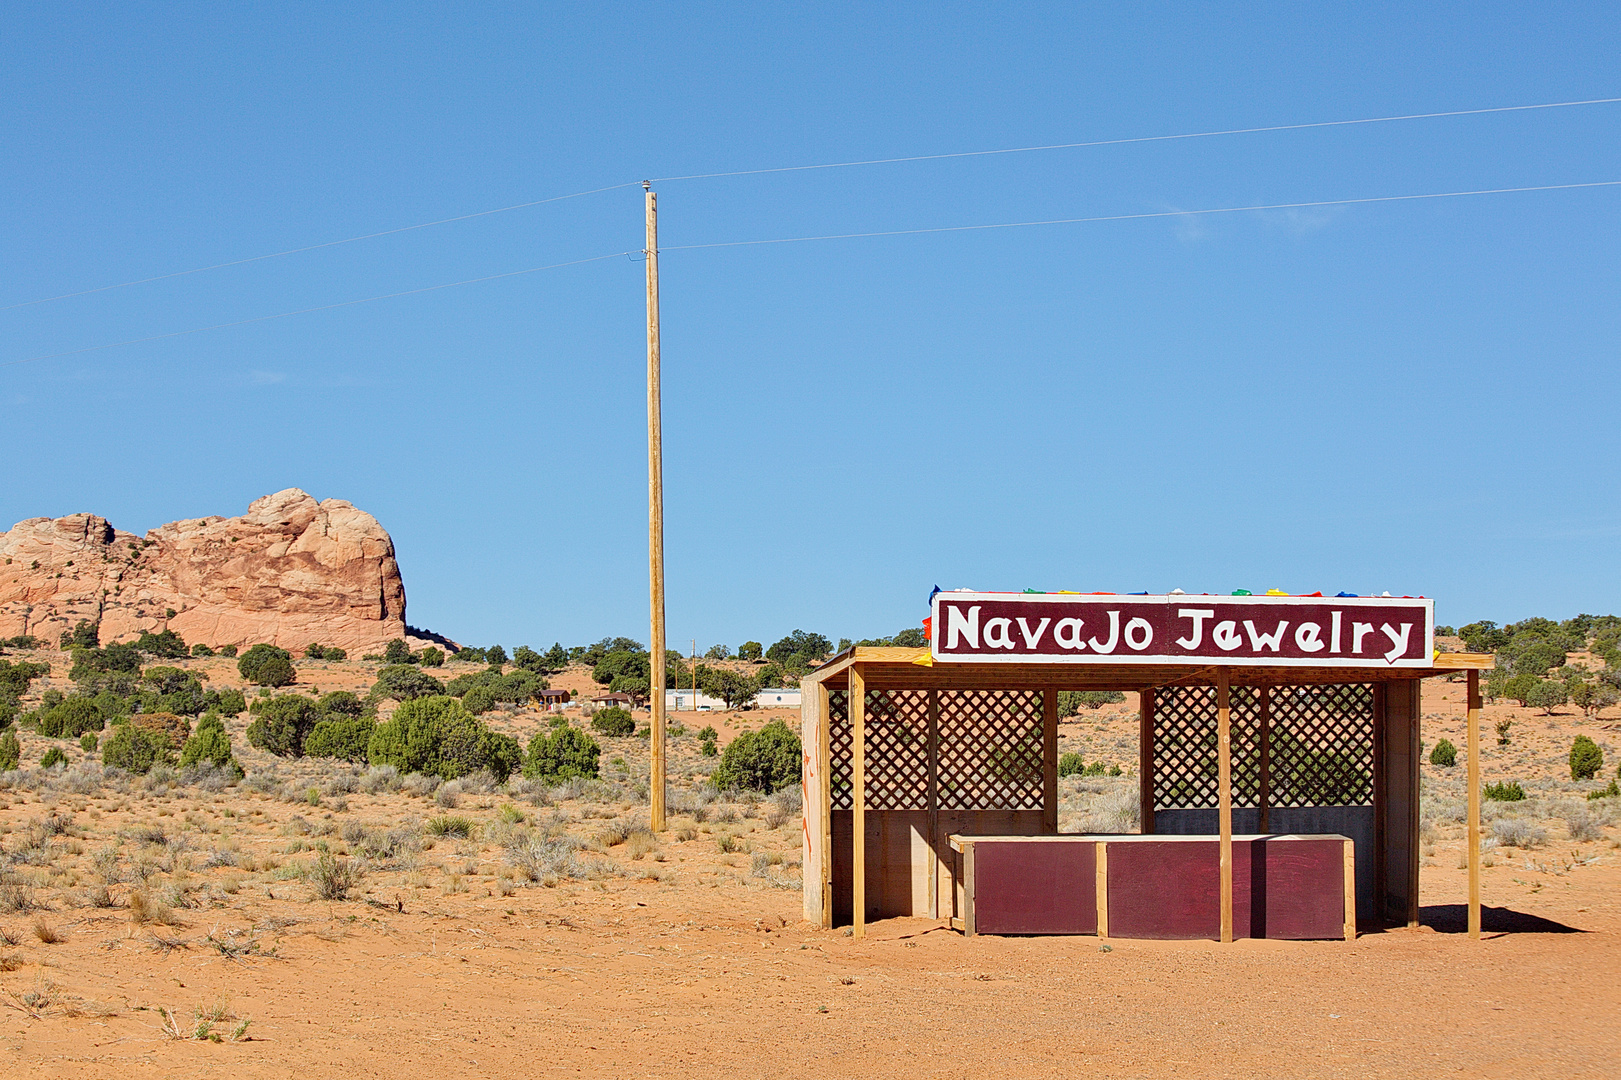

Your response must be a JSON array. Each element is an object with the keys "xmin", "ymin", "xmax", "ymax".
[{"xmin": 0, "ymin": 180, "xmax": 1621, "ymax": 368}]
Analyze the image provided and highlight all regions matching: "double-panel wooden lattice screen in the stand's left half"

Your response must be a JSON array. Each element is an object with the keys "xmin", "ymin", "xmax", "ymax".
[{"xmin": 828, "ymin": 689, "xmax": 1042, "ymax": 809}]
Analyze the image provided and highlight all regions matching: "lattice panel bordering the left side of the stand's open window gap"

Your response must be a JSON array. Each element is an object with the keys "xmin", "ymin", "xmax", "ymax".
[{"xmin": 940, "ymin": 691, "xmax": 1042, "ymax": 809}]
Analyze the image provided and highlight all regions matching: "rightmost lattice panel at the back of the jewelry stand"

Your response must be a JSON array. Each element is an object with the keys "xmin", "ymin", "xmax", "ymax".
[{"xmin": 1272, "ymin": 683, "xmax": 1373, "ymax": 806}]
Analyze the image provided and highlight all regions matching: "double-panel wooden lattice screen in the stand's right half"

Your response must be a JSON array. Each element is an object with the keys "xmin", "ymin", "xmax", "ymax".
[{"xmin": 1154, "ymin": 683, "xmax": 1373, "ymax": 809}]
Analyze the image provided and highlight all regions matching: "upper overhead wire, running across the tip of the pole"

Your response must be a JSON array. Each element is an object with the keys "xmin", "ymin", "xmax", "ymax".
[{"xmin": 0, "ymin": 97, "xmax": 1621, "ymax": 311}]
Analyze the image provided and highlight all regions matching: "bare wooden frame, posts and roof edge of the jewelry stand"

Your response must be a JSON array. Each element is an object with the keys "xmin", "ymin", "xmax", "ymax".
[{"xmin": 801, "ymin": 647, "xmax": 1493, "ymax": 941}]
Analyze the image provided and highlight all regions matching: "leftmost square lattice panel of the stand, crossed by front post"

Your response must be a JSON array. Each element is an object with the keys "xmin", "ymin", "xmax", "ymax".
[{"xmin": 827, "ymin": 691, "xmax": 929, "ymax": 809}]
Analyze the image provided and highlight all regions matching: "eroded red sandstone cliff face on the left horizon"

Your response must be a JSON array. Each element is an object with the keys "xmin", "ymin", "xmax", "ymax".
[{"xmin": 0, "ymin": 488, "xmax": 405, "ymax": 654}]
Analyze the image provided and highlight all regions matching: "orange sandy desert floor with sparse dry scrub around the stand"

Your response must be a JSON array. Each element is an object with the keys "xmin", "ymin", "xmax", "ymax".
[{"xmin": 0, "ymin": 642, "xmax": 1621, "ymax": 1077}]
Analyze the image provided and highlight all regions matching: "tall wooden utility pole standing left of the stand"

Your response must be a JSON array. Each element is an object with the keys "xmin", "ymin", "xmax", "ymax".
[{"xmin": 642, "ymin": 180, "xmax": 665, "ymax": 832}]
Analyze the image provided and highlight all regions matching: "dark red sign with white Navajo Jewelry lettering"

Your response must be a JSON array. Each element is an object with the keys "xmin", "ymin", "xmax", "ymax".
[{"xmin": 929, "ymin": 592, "xmax": 1435, "ymax": 668}]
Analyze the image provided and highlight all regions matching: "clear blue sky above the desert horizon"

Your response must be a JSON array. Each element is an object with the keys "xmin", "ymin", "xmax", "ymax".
[{"xmin": 0, "ymin": 3, "xmax": 1621, "ymax": 647}]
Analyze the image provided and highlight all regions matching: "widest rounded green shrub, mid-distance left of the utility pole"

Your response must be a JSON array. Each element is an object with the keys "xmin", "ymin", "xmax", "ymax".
[{"xmin": 366, "ymin": 694, "xmax": 522, "ymax": 780}]
